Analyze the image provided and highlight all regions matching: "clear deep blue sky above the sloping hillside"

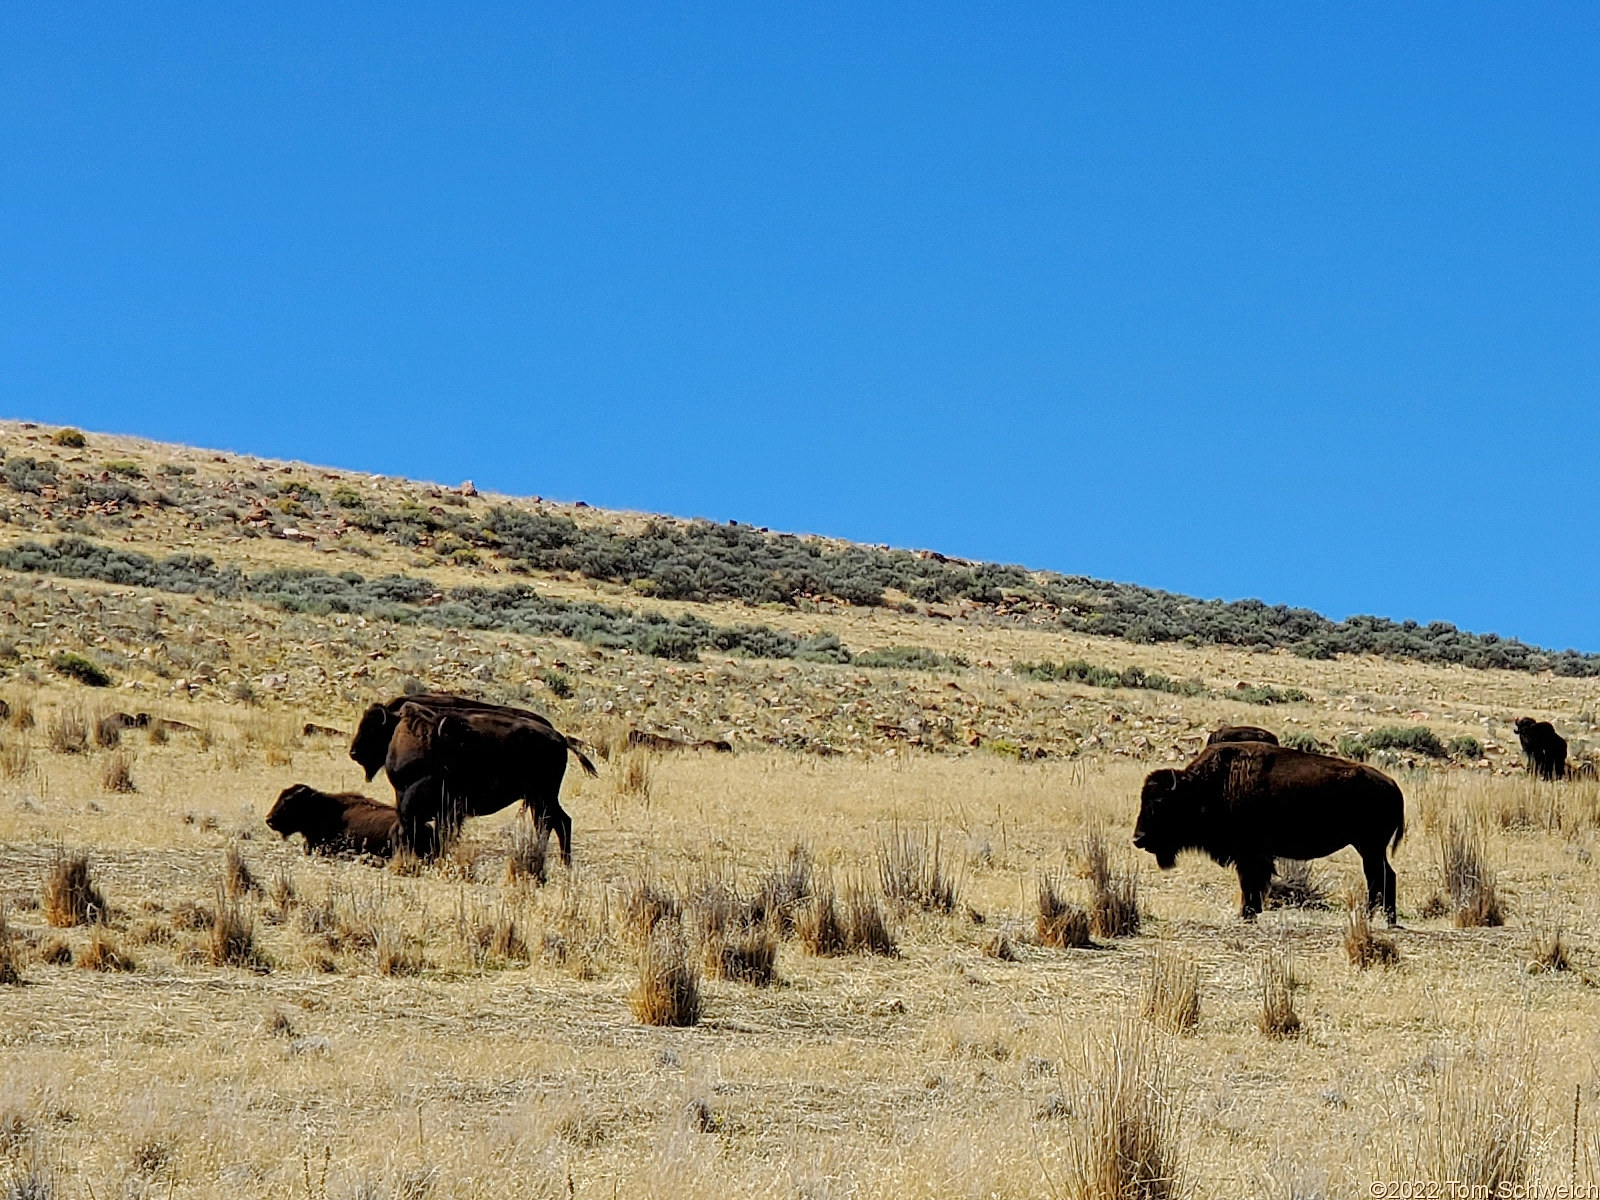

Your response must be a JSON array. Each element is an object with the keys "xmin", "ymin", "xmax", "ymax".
[{"xmin": 0, "ymin": 3, "xmax": 1600, "ymax": 650}]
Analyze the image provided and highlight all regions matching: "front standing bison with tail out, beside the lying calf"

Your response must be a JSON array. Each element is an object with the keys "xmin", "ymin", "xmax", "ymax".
[{"xmin": 384, "ymin": 702, "xmax": 597, "ymax": 866}]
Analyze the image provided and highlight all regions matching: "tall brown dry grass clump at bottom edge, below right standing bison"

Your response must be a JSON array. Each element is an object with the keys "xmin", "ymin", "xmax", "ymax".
[{"xmin": 1069, "ymin": 1021, "xmax": 1187, "ymax": 1200}]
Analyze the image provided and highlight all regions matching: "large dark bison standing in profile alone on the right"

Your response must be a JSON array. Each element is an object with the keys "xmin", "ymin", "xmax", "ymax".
[{"xmin": 1133, "ymin": 742, "xmax": 1405, "ymax": 925}]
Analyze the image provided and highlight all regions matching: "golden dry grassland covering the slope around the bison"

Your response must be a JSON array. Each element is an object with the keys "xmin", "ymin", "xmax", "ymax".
[{"xmin": 0, "ymin": 427, "xmax": 1600, "ymax": 1200}]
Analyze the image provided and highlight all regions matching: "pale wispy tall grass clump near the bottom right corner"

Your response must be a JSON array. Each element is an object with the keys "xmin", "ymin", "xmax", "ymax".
[{"xmin": 1413, "ymin": 1046, "xmax": 1534, "ymax": 1195}]
